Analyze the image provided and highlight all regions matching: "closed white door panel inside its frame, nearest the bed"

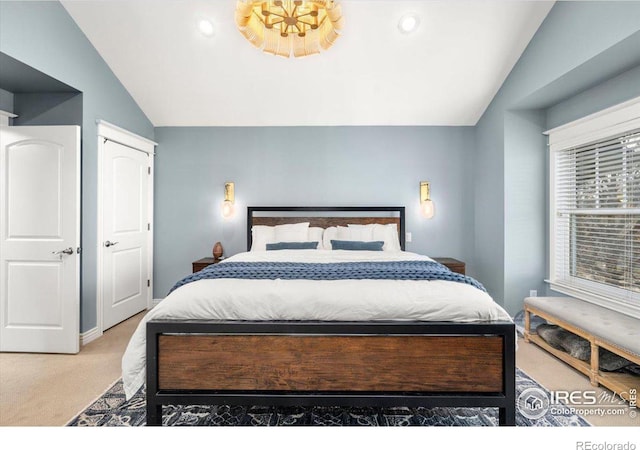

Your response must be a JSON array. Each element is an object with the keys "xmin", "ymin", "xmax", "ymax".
[{"xmin": 101, "ymin": 140, "xmax": 150, "ymax": 330}]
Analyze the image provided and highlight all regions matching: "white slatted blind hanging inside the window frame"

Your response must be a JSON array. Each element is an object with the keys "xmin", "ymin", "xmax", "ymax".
[{"xmin": 552, "ymin": 129, "xmax": 640, "ymax": 305}]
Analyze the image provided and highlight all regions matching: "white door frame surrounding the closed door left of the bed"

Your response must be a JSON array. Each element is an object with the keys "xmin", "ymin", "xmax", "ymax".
[{"xmin": 95, "ymin": 120, "xmax": 158, "ymax": 337}]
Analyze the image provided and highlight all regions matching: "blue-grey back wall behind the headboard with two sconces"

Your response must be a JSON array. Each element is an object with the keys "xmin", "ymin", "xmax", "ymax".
[{"xmin": 154, "ymin": 127, "xmax": 475, "ymax": 298}]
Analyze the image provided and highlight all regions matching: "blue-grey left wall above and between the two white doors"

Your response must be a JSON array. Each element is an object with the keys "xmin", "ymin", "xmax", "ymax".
[{"xmin": 0, "ymin": 1, "xmax": 153, "ymax": 331}]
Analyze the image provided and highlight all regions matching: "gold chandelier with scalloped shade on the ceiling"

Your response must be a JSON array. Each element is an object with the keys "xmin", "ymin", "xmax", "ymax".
[{"xmin": 236, "ymin": 0, "xmax": 344, "ymax": 58}]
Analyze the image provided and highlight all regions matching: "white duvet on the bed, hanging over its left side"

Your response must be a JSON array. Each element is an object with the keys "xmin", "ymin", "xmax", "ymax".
[{"xmin": 122, "ymin": 250, "xmax": 511, "ymax": 399}]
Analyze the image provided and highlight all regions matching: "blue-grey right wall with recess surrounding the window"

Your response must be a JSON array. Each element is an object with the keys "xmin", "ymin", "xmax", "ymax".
[{"xmin": 474, "ymin": 2, "xmax": 640, "ymax": 314}]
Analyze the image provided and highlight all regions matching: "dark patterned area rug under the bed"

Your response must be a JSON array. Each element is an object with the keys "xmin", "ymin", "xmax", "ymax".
[{"xmin": 67, "ymin": 369, "xmax": 590, "ymax": 427}]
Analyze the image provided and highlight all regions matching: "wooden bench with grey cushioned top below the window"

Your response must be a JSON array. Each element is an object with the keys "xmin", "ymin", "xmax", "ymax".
[{"xmin": 524, "ymin": 297, "xmax": 640, "ymax": 401}]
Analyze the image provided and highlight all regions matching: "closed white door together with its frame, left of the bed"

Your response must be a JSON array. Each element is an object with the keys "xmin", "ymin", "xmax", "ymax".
[{"xmin": 97, "ymin": 121, "xmax": 157, "ymax": 334}]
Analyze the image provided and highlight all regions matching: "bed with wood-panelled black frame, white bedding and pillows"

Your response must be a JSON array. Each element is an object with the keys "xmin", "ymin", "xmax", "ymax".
[{"xmin": 123, "ymin": 207, "xmax": 516, "ymax": 425}]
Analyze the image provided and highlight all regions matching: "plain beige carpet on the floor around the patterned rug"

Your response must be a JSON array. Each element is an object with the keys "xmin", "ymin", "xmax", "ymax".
[{"xmin": 0, "ymin": 314, "xmax": 640, "ymax": 426}]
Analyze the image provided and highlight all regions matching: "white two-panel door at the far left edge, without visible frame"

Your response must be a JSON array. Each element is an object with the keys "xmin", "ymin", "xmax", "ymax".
[{"xmin": 0, "ymin": 126, "xmax": 80, "ymax": 353}]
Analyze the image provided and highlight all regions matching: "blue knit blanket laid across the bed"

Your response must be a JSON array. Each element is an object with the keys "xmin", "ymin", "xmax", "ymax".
[{"xmin": 169, "ymin": 261, "xmax": 486, "ymax": 293}]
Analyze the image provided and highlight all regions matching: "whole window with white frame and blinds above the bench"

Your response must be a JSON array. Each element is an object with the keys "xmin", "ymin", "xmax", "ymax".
[{"xmin": 548, "ymin": 100, "xmax": 640, "ymax": 316}]
